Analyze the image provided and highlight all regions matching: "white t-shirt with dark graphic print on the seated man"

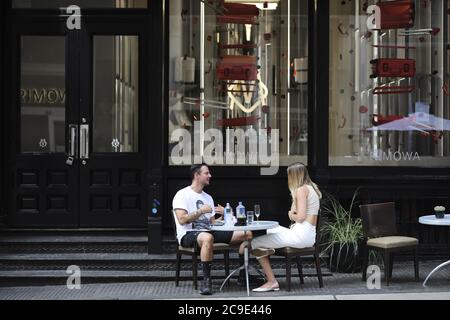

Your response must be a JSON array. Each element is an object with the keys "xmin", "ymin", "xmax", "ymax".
[{"xmin": 172, "ymin": 186, "xmax": 214, "ymax": 243}]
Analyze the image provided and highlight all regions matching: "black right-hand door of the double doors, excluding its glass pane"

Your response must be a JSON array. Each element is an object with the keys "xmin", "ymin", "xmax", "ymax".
[{"xmin": 79, "ymin": 17, "xmax": 152, "ymax": 228}]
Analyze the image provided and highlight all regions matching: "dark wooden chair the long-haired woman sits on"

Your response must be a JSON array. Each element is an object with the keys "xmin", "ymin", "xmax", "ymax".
[{"xmin": 274, "ymin": 218, "xmax": 323, "ymax": 291}]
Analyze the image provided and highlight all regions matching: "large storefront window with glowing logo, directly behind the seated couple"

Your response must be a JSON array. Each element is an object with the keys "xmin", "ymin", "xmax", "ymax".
[{"xmin": 169, "ymin": 0, "xmax": 308, "ymax": 166}]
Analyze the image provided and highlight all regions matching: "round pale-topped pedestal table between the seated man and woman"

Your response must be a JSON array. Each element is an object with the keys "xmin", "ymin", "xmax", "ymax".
[{"xmin": 211, "ymin": 221, "xmax": 279, "ymax": 296}]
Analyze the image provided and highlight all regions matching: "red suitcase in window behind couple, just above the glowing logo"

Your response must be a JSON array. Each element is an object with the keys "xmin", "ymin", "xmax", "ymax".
[{"xmin": 217, "ymin": 56, "xmax": 258, "ymax": 81}]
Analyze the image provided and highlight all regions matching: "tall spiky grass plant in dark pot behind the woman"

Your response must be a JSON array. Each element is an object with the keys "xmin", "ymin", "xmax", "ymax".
[{"xmin": 321, "ymin": 190, "xmax": 363, "ymax": 272}]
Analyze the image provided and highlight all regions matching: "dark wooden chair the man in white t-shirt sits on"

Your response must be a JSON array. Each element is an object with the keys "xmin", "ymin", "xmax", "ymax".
[{"xmin": 172, "ymin": 211, "xmax": 230, "ymax": 290}]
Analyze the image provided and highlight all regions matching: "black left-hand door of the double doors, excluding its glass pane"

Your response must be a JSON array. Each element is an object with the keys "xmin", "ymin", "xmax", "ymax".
[{"xmin": 6, "ymin": 16, "xmax": 80, "ymax": 228}]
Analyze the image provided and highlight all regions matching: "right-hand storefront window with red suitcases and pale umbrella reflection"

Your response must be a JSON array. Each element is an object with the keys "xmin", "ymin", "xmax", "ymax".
[{"xmin": 329, "ymin": 0, "xmax": 450, "ymax": 167}]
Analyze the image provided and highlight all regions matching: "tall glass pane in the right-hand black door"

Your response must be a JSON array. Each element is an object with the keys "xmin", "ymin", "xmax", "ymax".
[{"xmin": 93, "ymin": 35, "xmax": 139, "ymax": 153}]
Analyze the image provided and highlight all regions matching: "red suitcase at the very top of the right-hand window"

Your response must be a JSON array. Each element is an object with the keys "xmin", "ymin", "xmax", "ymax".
[{"xmin": 377, "ymin": 0, "xmax": 415, "ymax": 30}]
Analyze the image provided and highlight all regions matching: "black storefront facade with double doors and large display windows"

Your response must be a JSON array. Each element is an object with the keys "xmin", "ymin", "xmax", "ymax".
[{"xmin": 0, "ymin": 0, "xmax": 450, "ymax": 254}]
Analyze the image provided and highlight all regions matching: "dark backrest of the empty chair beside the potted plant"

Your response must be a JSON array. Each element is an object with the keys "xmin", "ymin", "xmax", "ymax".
[{"xmin": 359, "ymin": 202, "xmax": 397, "ymax": 238}]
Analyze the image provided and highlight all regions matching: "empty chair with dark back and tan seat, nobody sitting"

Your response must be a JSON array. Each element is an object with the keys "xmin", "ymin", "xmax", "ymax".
[{"xmin": 359, "ymin": 202, "xmax": 419, "ymax": 286}]
